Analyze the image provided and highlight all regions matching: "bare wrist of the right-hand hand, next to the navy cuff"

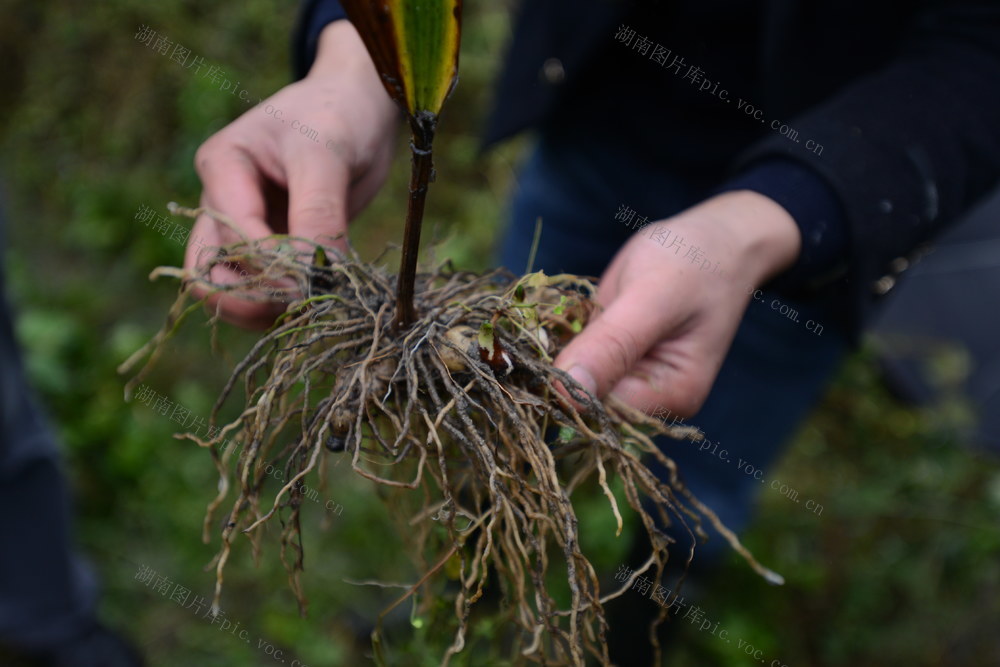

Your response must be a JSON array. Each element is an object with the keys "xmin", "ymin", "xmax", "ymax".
[{"xmin": 695, "ymin": 190, "xmax": 802, "ymax": 285}]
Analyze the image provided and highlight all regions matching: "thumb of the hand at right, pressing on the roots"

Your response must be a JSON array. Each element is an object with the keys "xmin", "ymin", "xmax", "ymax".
[{"xmin": 555, "ymin": 290, "xmax": 659, "ymax": 398}]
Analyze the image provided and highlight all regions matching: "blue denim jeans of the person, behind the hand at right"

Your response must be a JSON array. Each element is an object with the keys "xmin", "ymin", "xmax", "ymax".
[{"xmin": 500, "ymin": 133, "xmax": 849, "ymax": 565}]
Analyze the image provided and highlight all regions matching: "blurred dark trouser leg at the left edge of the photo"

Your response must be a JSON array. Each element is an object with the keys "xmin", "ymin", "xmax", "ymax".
[{"xmin": 0, "ymin": 198, "xmax": 97, "ymax": 650}]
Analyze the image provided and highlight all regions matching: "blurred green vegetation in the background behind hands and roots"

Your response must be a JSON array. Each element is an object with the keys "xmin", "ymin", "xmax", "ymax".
[{"xmin": 0, "ymin": 0, "xmax": 1000, "ymax": 667}]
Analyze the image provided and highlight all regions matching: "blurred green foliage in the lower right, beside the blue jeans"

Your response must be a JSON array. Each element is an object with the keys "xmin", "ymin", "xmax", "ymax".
[{"xmin": 670, "ymin": 353, "xmax": 1000, "ymax": 666}]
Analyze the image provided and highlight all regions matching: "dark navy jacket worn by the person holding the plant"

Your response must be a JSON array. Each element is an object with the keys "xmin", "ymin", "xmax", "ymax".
[{"xmin": 294, "ymin": 0, "xmax": 1000, "ymax": 334}]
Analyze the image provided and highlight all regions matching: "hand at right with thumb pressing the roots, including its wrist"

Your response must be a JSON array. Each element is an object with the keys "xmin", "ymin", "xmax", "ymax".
[{"xmin": 555, "ymin": 190, "xmax": 801, "ymax": 417}]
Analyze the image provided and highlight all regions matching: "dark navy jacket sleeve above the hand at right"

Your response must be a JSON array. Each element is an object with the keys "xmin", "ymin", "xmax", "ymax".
[{"xmin": 734, "ymin": 2, "xmax": 1000, "ymax": 328}]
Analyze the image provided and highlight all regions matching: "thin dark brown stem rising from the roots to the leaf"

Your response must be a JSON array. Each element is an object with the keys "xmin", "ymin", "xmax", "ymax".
[{"xmin": 395, "ymin": 112, "xmax": 437, "ymax": 331}]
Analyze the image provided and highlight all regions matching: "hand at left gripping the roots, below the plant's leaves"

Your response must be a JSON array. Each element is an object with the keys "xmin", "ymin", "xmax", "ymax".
[{"xmin": 184, "ymin": 21, "xmax": 399, "ymax": 328}]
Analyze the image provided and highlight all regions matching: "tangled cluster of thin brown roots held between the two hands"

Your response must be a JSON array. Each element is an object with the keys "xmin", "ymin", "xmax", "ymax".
[{"xmin": 123, "ymin": 211, "xmax": 777, "ymax": 665}]
